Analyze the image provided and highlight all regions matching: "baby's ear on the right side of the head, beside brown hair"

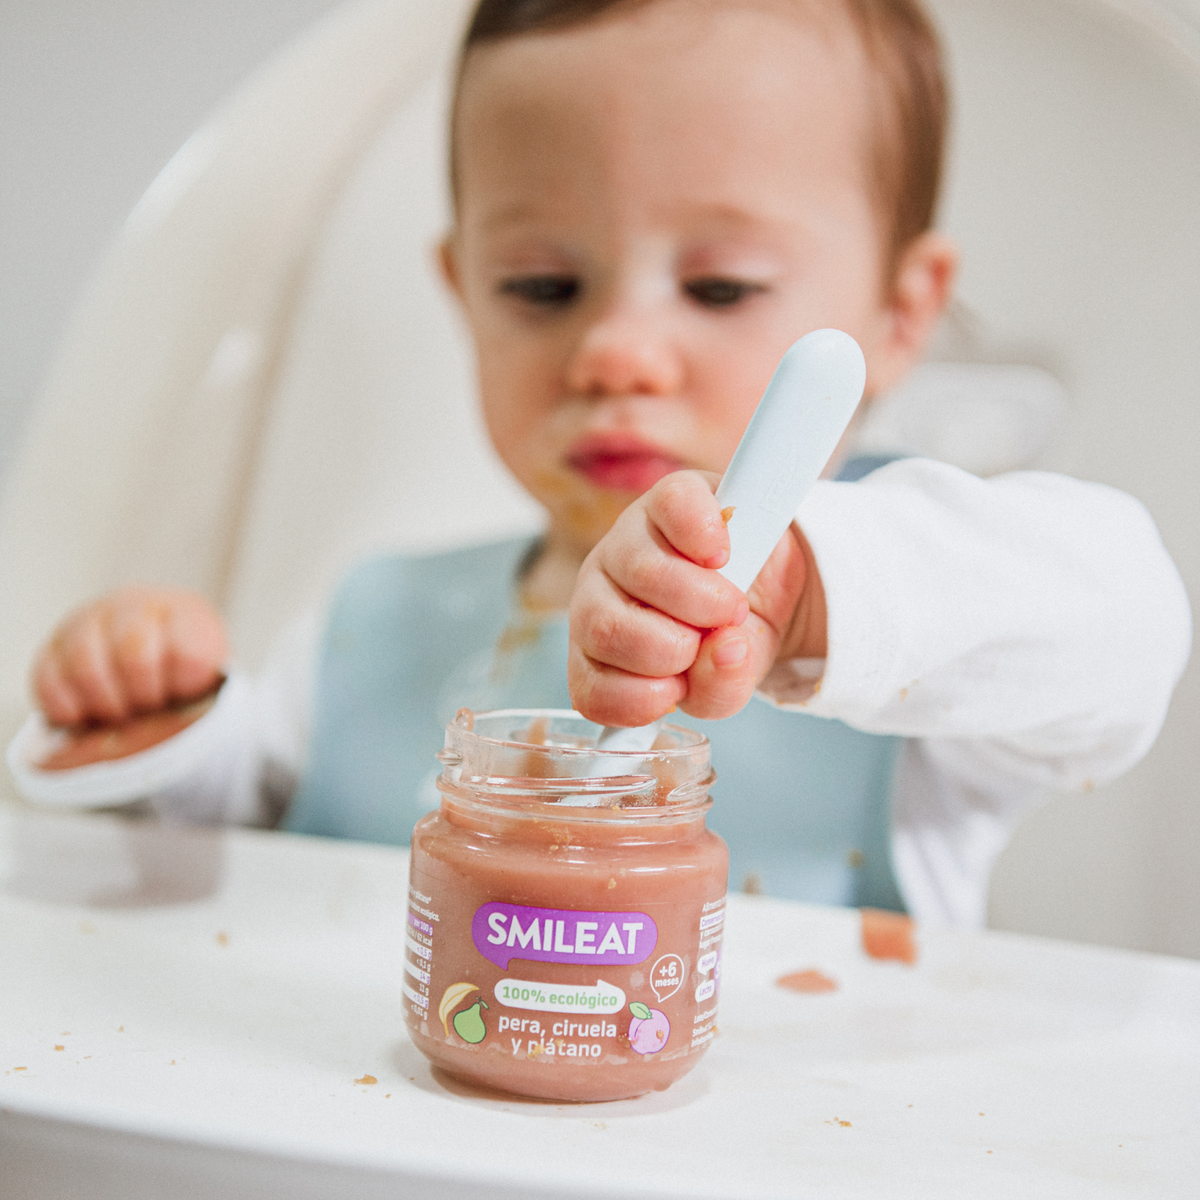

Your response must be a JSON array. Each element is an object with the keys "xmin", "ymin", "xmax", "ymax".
[{"xmin": 872, "ymin": 230, "xmax": 959, "ymax": 392}]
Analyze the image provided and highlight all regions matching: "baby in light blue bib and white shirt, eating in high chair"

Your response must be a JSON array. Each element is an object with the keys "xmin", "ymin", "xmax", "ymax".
[{"xmin": 18, "ymin": 0, "xmax": 1189, "ymax": 925}]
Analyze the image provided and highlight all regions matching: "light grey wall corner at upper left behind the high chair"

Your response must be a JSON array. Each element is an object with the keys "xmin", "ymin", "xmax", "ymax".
[{"xmin": 0, "ymin": 0, "xmax": 348, "ymax": 473}]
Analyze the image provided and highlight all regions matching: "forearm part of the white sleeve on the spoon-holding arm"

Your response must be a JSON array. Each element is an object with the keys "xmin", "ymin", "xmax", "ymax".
[{"xmin": 763, "ymin": 458, "xmax": 1190, "ymax": 768}]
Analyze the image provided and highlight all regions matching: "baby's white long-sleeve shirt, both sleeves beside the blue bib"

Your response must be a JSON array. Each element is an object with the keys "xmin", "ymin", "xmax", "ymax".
[{"xmin": 9, "ymin": 458, "xmax": 1190, "ymax": 928}]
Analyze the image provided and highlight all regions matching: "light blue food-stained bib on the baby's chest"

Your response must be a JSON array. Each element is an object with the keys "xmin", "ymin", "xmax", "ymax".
[{"xmin": 284, "ymin": 463, "xmax": 904, "ymax": 910}]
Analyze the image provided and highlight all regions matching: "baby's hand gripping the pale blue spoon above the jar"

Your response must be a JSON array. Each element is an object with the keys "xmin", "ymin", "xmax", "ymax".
[{"xmin": 568, "ymin": 470, "xmax": 824, "ymax": 726}]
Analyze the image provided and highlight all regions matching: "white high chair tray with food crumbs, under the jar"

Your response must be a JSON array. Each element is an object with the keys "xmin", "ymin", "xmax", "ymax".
[{"xmin": 0, "ymin": 812, "xmax": 1200, "ymax": 1200}]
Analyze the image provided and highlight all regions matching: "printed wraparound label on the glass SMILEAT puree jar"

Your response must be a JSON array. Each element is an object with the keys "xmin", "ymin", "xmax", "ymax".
[{"xmin": 404, "ymin": 886, "xmax": 725, "ymax": 1068}]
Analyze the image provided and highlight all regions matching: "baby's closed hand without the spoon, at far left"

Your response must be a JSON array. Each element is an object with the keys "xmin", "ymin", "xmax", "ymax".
[{"xmin": 34, "ymin": 588, "xmax": 227, "ymax": 726}]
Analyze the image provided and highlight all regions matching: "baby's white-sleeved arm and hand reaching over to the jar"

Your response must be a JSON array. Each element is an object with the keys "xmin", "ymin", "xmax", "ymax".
[{"xmin": 571, "ymin": 460, "xmax": 1190, "ymax": 925}]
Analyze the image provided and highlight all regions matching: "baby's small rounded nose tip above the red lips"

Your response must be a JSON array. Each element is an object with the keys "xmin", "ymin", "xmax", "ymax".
[{"xmin": 566, "ymin": 313, "xmax": 684, "ymax": 396}]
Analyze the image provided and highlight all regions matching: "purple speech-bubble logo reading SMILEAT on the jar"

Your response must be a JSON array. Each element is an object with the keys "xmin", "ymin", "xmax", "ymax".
[{"xmin": 470, "ymin": 901, "xmax": 659, "ymax": 969}]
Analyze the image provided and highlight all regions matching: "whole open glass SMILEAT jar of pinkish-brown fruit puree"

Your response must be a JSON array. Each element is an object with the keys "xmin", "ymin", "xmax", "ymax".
[{"xmin": 404, "ymin": 709, "xmax": 728, "ymax": 1100}]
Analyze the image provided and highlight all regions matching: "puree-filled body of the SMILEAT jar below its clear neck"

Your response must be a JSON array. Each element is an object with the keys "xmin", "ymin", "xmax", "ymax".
[{"xmin": 402, "ymin": 827, "xmax": 725, "ymax": 1100}]
